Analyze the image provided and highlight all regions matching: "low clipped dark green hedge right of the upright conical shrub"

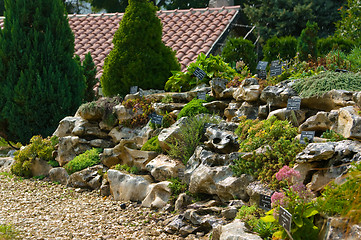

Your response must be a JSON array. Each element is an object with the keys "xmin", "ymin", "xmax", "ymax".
[{"xmin": 317, "ymin": 36, "xmax": 355, "ymax": 56}]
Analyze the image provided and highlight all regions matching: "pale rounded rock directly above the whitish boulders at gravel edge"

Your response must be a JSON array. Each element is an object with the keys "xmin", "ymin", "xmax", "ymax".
[{"xmin": 145, "ymin": 155, "xmax": 185, "ymax": 181}]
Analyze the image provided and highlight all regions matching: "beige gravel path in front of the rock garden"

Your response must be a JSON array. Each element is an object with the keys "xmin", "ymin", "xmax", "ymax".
[{"xmin": 0, "ymin": 168, "xmax": 194, "ymax": 240}]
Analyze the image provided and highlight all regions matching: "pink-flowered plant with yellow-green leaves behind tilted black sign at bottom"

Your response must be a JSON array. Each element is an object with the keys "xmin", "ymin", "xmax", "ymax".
[{"xmin": 261, "ymin": 166, "xmax": 319, "ymax": 240}]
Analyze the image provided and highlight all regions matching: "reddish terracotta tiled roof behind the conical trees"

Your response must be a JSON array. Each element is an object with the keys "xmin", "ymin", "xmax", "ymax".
[{"xmin": 0, "ymin": 6, "xmax": 240, "ymax": 77}]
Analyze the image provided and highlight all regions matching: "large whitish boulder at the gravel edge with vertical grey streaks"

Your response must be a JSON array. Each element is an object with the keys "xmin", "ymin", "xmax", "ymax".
[{"xmin": 107, "ymin": 169, "xmax": 150, "ymax": 201}]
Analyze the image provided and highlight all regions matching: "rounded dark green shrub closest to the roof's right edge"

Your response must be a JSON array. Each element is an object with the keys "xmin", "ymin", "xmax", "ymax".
[{"xmin": 222, "ymin": 38, "xmax": 257, "ymax": 72}]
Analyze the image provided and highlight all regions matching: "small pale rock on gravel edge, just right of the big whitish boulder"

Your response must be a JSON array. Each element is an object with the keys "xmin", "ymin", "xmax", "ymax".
[{"xmin": 142, "ymin": 181, "xmax": 172, "ymax": 209}]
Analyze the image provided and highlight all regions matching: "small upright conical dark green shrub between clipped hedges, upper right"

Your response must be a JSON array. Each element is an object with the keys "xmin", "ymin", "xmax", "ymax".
[{"xmin": 297, "ymin": 21, "xmax": 318, "ymax": 61}]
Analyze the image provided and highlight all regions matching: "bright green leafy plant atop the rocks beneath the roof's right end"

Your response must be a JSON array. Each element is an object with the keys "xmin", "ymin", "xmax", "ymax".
[{"xmin": 164, "ymin": 53, "xmax": 237, "ymax": 92}]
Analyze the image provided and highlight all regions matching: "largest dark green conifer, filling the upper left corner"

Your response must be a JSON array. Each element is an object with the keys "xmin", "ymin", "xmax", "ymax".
[{"xmin": 0, "ymin": 0, "xmax": 85, "ymax": 143}]
